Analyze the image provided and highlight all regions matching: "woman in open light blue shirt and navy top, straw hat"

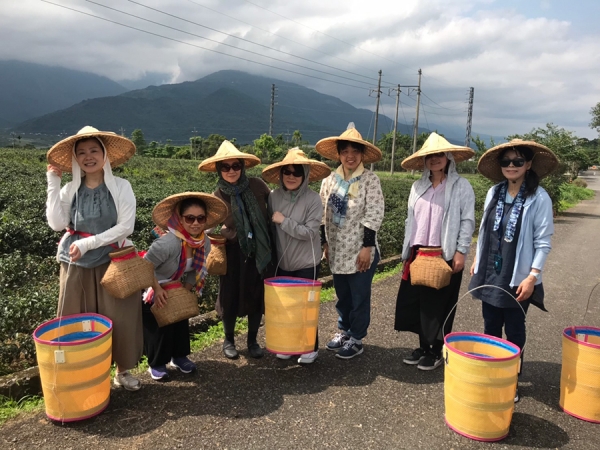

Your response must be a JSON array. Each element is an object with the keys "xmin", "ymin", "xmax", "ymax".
[{"xmin": 469, "ymin": 139, "xmax": 558, "ymax": 402}]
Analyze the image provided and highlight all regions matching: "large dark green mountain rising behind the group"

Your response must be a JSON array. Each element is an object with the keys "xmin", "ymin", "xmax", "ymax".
[{"xmin": 14, "ymin": 70, "xmax": 421, "ymax": 144}]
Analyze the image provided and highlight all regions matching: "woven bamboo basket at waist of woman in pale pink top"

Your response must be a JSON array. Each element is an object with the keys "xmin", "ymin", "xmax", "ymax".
[{"xmin": 410, "ymin": 247, "xmax": 452, "ymax": 289}]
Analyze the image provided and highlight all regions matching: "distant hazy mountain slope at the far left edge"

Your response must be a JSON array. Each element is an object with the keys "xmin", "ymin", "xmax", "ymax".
[{"xmin": 0, "ymin": 60, "xmax": 127, "ymax": 128}]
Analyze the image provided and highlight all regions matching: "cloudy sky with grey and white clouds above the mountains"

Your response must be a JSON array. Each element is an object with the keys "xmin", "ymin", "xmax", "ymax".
[{"xmin": 0, "ymin": 0, "xmax": 600, "ymax": 138}]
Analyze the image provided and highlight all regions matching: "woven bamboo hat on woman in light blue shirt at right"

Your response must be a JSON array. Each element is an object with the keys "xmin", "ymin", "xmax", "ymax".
[{"xmin": 477, "ymin": 139, "xmax": 558, "ymax": 181}]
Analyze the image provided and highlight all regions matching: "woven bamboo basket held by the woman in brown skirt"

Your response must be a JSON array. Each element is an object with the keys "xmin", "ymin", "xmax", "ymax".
[{"xmin": 100, "ymin": 246, "xmax": 154, "ymax": 298}]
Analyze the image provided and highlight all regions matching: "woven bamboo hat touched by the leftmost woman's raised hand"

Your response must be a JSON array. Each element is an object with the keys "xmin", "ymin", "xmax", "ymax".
[{"xmin": 46, "ymin": 126, "xmax": 135, "ymax": 172}]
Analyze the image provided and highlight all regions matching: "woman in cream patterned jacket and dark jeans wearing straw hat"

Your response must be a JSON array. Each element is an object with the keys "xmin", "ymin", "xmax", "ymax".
[{"xmin": 315, "ymin": 123, "xmax": 384, "ymax": 359}]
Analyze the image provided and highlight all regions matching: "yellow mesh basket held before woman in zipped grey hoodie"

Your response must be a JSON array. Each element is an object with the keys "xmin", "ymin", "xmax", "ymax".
[{"xmin": 265, "ymin": 277, "xmax": 321, "ymax": 355}]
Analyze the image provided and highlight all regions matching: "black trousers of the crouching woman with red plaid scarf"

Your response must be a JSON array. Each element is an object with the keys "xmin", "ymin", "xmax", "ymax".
[{"xmin": 142, "ymin": 303, "xmax": 191, "ymax": 367}]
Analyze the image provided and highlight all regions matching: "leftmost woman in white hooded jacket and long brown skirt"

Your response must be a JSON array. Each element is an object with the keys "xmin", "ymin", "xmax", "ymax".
[{"xmin": 46, "ymin": 126, "xmax": 143, "ymax": 391}]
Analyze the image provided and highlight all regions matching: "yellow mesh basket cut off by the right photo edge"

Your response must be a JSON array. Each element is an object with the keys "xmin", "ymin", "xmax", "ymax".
[{"xmin": 560, "ymin": 327, "xmax": 600, "ymax": 423}]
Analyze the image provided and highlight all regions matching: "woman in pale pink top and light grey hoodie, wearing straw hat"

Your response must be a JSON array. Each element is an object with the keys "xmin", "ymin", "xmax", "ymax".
[{"xmin": 394, "ymin": 133, "xmax": 475, "ymax": 370}]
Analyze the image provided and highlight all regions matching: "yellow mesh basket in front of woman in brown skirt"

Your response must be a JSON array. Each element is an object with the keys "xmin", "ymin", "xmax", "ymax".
[{"xmin": 33, "ymin": 313, "xmax": 112, "ymax": 422}]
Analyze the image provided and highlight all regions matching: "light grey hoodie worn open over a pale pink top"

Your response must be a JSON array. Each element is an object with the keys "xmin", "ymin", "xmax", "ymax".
[{"xmin": 402, "ymin": 152, "xmax": 475, "ymax": 261}]
